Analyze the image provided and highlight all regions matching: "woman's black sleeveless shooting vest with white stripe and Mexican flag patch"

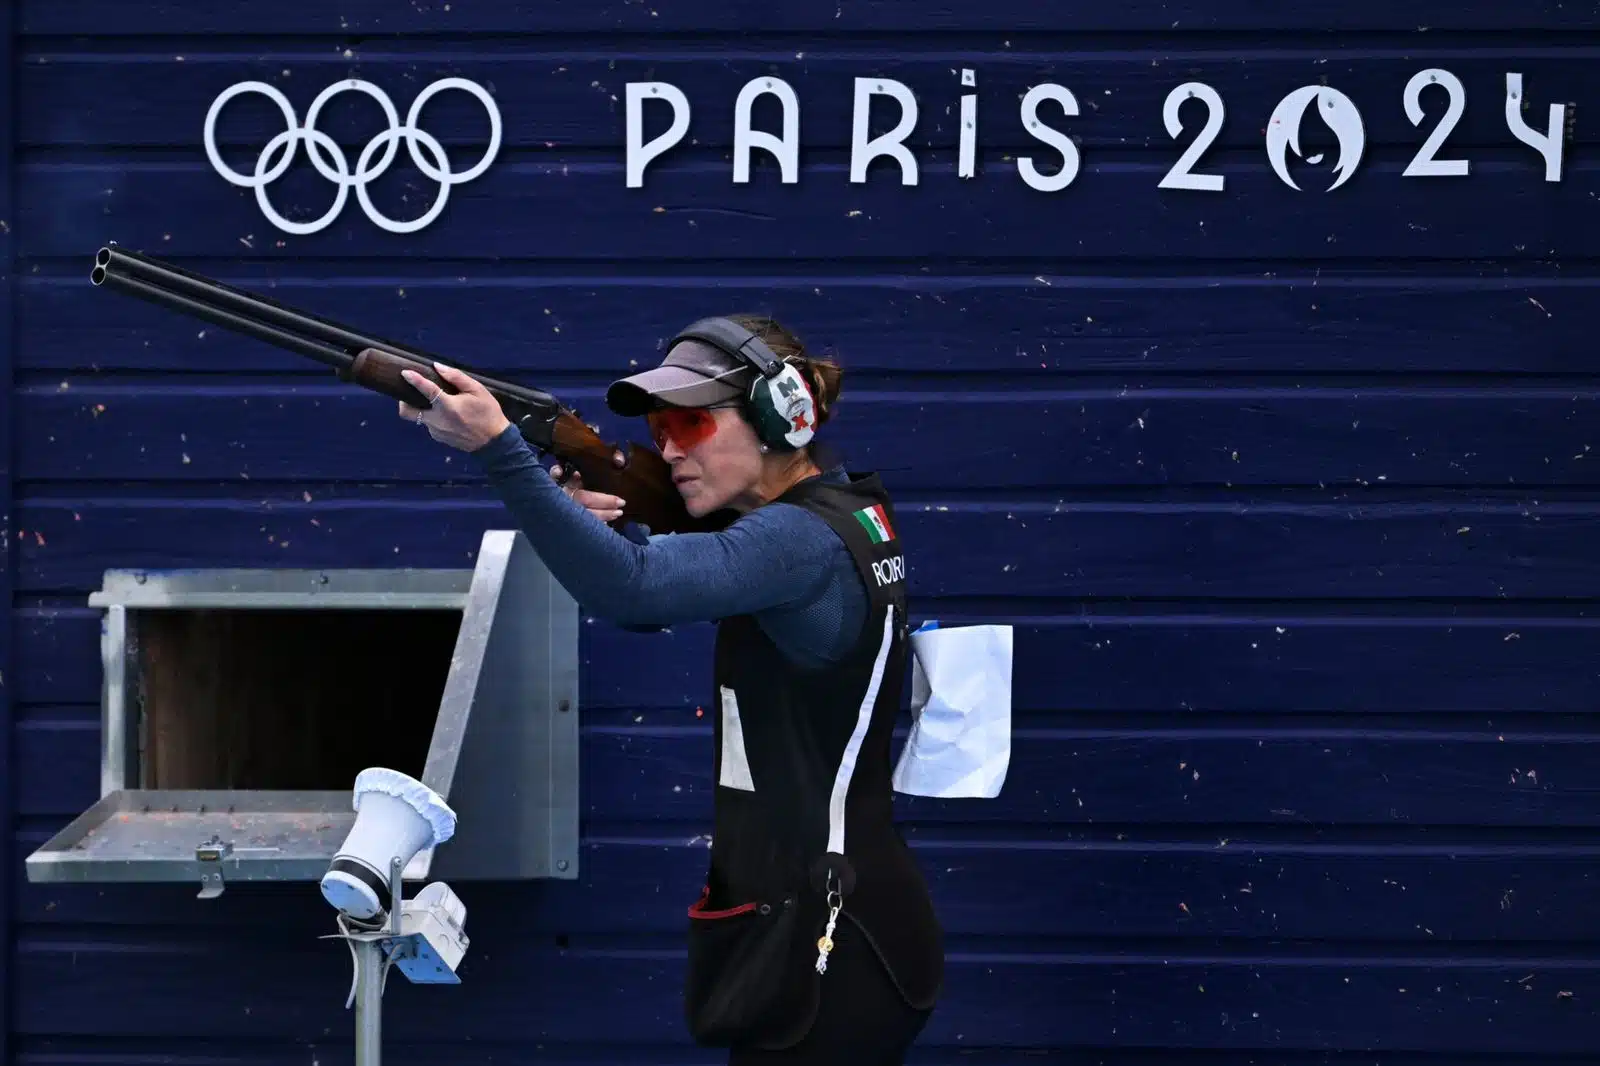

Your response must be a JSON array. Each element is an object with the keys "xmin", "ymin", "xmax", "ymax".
[{"xmin": 685, "ymin": 474, "xmax": 944, "ymax": 1047}]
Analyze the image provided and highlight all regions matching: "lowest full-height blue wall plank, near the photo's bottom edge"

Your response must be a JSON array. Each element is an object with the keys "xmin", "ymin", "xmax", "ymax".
[{"xmin": 13, "ymin": 912, "xmax": 1600, "ymax": 1055}]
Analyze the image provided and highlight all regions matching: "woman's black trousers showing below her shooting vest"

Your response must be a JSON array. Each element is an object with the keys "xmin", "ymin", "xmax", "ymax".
[{"xmin": 728, "ymin": 920, "xmax": 933, "ymax": 1066}]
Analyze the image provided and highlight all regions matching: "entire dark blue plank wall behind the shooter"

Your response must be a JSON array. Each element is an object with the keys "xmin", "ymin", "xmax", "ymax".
[{"xmin": 0, "ymin": 0, "xmax": 1600, "ymax": 1066}]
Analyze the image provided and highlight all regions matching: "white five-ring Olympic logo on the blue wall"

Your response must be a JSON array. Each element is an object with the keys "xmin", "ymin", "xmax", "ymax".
[{"xmin": 205, "ymin": 78, "xmax": 501, "ymax": 234}]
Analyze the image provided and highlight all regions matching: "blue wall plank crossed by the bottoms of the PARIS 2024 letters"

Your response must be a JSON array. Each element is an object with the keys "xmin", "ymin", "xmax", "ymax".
[{"xmin": 16, "ymin": 160, "xmax": 1600, "ymax": 264}]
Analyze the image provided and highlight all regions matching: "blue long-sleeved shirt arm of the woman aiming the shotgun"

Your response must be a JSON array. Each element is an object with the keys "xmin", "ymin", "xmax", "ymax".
[{"xmin": 472, "ymin": 427, "xmax": 867, "ymax": 666}]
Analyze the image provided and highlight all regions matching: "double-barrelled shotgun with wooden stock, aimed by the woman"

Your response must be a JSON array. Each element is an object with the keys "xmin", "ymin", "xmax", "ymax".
[{"xmin": 90, "ymin": 243, "xmax": 731, "ymax": 533}]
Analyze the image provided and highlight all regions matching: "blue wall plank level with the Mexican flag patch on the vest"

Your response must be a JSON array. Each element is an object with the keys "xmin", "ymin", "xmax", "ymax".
[{"xmin": 13, "ymin": 496, "xmax": 1600, "ymax": 600}]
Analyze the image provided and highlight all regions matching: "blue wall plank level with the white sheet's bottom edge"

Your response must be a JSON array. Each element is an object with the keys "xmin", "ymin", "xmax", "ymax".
[{"xmin": 16, "ymin": 711, "xmax": 1600, "ymax": 828}]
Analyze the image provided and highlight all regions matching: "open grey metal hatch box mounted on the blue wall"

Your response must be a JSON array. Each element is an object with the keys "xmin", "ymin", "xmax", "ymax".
[{"xmin": 27, "ymin": 530, "xmax": 579, "ymax": 896}]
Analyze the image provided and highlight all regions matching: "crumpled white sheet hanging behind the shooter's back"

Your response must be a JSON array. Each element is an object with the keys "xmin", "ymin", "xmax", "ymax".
[{"xmin": 894, "ymin": 623, "xmax": 1011, "ymax": 799}]
